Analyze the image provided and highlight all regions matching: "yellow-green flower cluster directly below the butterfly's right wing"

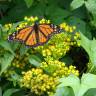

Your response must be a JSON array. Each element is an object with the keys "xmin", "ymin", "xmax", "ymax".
[{"xmin": 35, "ymin": 33, "xmax": 75, "ymax": 59}]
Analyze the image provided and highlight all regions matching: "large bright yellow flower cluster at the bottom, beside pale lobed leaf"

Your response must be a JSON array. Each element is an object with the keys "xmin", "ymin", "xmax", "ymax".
[{"xmin": 20, "ymin": 60, "xmax": 79, "ymax": 96}]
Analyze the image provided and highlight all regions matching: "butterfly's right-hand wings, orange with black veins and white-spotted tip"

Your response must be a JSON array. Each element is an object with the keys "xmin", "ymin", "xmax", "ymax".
[{"xmin": 38, "ymin": 24, "xmax": 61, "ymax": 45}]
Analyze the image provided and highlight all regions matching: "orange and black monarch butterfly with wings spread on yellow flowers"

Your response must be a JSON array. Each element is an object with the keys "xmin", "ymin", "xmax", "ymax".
[{"xmin": 8, "ymin": 22, "xmax": 61, "ymax": 47}]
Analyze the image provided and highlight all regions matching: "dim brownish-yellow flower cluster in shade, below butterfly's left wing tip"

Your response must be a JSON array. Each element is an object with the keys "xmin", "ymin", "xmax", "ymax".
[{"xmin": 4, "ymin": 53, "xmax": 29, "ymax": 77}]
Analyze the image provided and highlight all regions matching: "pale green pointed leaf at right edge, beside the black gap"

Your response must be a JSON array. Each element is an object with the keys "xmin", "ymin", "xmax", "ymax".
[{"xmin": 80, "ymin": 34, "xmax": 96, "ymax": 74}]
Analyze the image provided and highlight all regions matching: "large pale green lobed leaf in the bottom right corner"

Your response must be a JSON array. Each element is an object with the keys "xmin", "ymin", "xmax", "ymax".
[{"xmin": 57, "ymin": 73, "xmax": 96, "ymax": 96}]
